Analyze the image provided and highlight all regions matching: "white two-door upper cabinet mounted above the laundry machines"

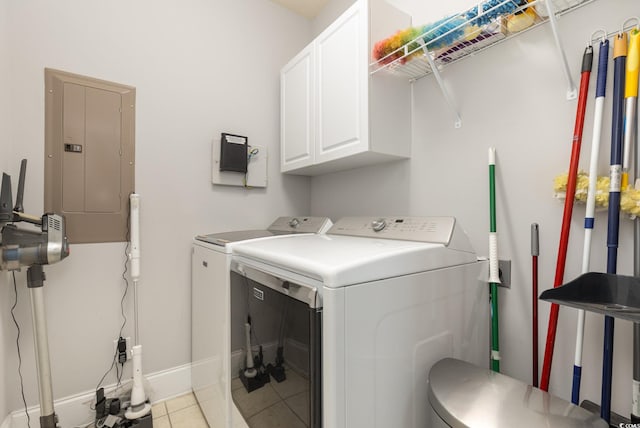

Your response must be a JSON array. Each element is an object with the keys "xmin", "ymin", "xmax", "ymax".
[{"xmin": 280, "ymin": 0, "xmax": 411, "ymax": 175}]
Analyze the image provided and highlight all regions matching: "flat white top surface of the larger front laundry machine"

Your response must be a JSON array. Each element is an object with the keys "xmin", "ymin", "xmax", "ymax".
[{"xmin": 233, "ymin": 235, "xmax": 477, "ymax": 288}]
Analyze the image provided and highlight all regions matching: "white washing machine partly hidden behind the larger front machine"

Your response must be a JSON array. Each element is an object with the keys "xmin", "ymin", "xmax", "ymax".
[{"xmin": 191, "ymin": 217, "xmax": 332, "ymax": 428}]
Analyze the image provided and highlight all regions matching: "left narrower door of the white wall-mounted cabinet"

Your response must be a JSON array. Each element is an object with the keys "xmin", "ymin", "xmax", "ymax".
[{"xmin": 280, "ymin": 44, "xmax": 315, "ymax": 172}]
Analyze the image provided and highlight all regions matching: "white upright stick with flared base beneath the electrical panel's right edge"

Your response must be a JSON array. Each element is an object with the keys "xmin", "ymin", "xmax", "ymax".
[{"xmin": 124, "ymin": 193, "xmax": 151, "ymax": 419}]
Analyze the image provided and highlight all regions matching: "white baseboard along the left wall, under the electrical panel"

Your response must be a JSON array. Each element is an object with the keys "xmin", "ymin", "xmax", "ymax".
[{"xmin": 10, "ymin": 364, "xmax": 191, "ymax": 428}]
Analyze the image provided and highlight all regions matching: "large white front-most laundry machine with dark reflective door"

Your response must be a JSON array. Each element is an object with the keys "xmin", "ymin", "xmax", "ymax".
[{"xmin": 230, "ymin": 217, "xmax": 490, "ymax": 428}]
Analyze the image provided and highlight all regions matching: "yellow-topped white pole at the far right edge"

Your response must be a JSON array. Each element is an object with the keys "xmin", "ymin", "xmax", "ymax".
[{"xmin": 625, "ymin": 28, "xmax": 640, "ymax": 423}]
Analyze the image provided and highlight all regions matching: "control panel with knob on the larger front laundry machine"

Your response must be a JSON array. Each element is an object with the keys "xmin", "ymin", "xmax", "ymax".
[{"xmin": 327, "ymin": 217, "xmax": 456, "ymax": 245}]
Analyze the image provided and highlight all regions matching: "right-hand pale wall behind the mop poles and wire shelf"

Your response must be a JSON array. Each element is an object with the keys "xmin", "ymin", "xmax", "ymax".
[{"xmin": 311, "ymin": 0, "xmax": 637, "ymax": 416}]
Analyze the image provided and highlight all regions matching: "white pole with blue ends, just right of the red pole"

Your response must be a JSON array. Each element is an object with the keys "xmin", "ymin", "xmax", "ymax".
[{"xmin": 571, "ymin": 33, "xmax": 609, "ymax": 405}]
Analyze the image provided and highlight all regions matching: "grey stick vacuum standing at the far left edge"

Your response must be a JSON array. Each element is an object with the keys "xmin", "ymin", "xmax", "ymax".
[{"xmin": 0, "ymin": 159, "xmax": 69, "ymax": 428}]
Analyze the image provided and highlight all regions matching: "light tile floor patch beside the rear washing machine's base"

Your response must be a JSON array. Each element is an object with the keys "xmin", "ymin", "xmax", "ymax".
[{"xmin": 151, "ymin": 393, "xmax": 209, "ymax": 428}]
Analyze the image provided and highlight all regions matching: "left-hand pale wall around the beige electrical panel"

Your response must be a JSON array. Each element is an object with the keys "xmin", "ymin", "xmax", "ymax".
[{"xmin": 0, "ymin": 0, "xmax": 310, "ymax": 418}]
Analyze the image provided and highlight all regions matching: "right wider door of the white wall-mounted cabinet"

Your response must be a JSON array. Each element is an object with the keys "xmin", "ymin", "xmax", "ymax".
[{"xmin": 315, "ymin": 0, "xmax": 368, "ymax": 163}]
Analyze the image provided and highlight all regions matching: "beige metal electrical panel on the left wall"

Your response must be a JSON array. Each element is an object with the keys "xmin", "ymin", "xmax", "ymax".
[{"xmin": 44, "ymin": 69, "xmax": 135, "ymax": 244}]
